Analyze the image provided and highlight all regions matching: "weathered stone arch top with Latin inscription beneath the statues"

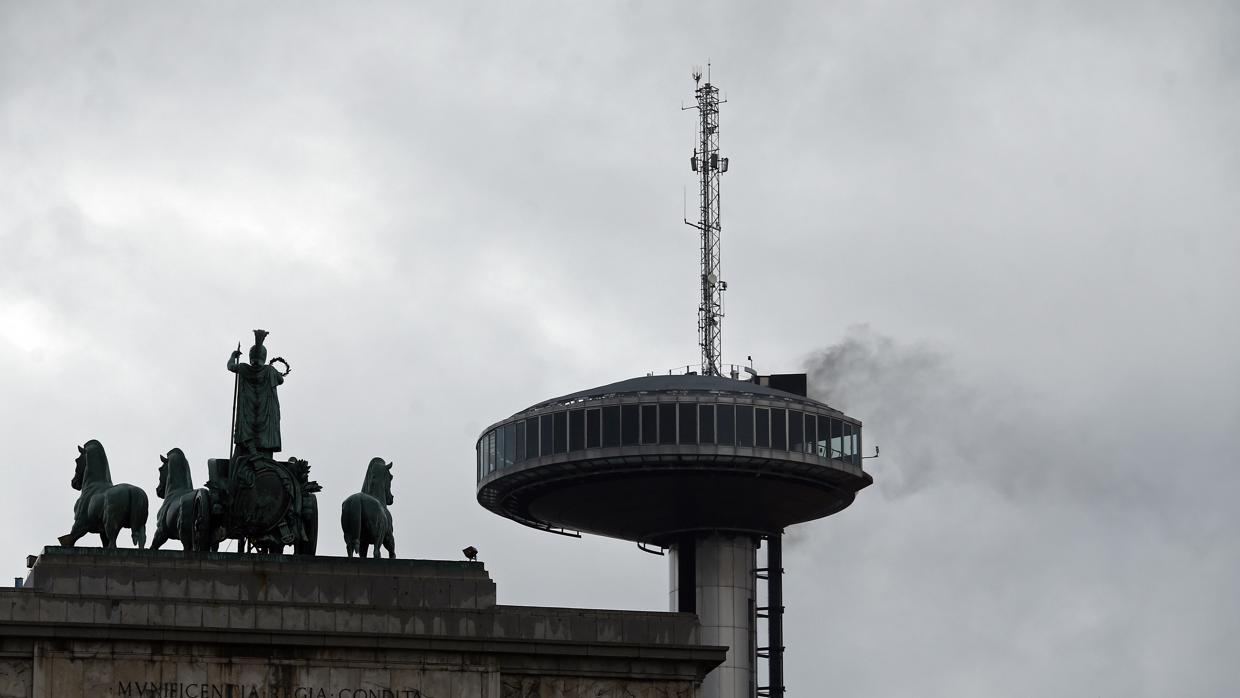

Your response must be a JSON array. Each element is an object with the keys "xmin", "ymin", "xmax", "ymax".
[{"xmin": 0, "ymin": 548, "xmax": 725, "ymax": 698}]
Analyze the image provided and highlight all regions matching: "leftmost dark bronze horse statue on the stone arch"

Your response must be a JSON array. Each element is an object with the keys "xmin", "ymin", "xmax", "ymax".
[{"xmin": 60, "ymin": 439, "xmax": 146, "ymax": 548}]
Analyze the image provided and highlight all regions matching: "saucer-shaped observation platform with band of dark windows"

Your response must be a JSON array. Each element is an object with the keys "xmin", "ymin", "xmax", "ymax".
[{"xmin": 477, "ymin": 374, "xmax": 873, "ymax": 544}]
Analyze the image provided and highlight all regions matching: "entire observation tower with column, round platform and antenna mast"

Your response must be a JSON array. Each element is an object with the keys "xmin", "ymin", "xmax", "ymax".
[{"xmin": 477, "ymin": 72, "xmax": 873, "ymax": 698}]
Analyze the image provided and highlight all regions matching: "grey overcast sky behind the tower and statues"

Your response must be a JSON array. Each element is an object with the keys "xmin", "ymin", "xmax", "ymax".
[{"xmin": 0, "ymin": 0, "xmax": 1240, "ymax": 698}]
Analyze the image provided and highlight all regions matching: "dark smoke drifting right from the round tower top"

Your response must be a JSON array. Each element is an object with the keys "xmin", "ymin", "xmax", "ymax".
[{"xmin": 807, "ymin": 326, "xmax": 1140, "ymax": 497}]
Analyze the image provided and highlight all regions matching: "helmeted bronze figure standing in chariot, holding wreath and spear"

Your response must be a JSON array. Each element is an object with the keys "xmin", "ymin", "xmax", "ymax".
[{"xmin": 228, "ymin": 330, "xmax": 289, "ymax": 455}]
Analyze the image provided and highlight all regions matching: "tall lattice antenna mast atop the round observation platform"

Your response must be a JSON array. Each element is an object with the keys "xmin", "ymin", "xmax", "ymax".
[{"xmin": 682, "ymin": 64, "xmax": 728, "ymax": 376}]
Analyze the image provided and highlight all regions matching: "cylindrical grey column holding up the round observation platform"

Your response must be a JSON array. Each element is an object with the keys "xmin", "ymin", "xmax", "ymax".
[{"xmin": 670, "ymin": 533, "xmax": 758, "ymax": 698}]
